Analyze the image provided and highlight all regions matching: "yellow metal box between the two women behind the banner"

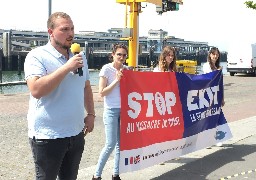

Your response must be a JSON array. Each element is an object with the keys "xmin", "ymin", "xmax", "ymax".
[{"xmin": 176, "ymin": 60, "xmax": 197, "ymax": 74}]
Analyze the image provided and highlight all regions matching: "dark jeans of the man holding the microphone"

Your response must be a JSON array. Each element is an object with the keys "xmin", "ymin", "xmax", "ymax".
[{"xmin": 29, "ymin": 132, "xmax": 85, "ymax": 180}]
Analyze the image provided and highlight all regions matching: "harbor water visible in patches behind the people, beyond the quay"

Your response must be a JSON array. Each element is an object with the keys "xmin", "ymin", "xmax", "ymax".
[{"xmin": 0, "ymin": 62, "xmax": 227, "ymax": 94}]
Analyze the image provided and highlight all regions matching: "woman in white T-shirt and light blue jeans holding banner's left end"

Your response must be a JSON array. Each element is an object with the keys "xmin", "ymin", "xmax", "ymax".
[{"xmin": 92, "ymin": 44, "xmax": 128, "ymax": 180}]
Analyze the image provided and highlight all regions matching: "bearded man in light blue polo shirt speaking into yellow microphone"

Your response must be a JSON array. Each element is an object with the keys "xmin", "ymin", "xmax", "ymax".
[{"xmin": 24, "ymin": 12, "xmax": 95, "ymax": 180}]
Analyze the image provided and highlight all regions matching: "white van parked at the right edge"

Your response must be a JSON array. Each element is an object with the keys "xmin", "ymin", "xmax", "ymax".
[{"xmin": 227, "ymin": 43, "xmax": 256, "ymax": 76}]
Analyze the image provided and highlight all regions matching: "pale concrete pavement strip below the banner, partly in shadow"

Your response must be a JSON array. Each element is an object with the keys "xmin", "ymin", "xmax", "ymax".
[{"xmin": 78, "ymin": 116, "xmax": 256, "ymax": 180}]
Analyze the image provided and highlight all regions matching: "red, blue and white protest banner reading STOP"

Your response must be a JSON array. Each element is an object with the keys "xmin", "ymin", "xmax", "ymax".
[{"xmin": 119, "ymin": 70, "xmax": 232, "ymax": 173}]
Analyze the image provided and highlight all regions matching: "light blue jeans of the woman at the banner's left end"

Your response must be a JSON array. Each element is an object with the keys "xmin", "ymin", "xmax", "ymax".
[{"xmin": 95, "ymin": 108, "xmax": 120, "ymax": 177}]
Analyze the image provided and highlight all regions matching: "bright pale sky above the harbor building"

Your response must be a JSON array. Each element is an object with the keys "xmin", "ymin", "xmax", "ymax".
[{"xmin": 0, "ymin": 0, "xmax": 256, "ymax": 50}]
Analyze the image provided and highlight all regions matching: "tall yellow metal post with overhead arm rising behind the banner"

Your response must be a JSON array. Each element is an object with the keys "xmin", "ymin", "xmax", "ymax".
[{"xmin": 116, "ymin": 0, "xmax": 183, "ymax": 68}]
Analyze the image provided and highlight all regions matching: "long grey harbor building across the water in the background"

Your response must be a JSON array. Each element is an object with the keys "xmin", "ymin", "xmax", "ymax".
[{"xmin": 0, "ymin": 28, "xmax": 226, "ymax": 71}]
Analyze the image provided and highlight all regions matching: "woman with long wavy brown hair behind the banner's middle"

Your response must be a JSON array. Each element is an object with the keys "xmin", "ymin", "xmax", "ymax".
[{"xmin": 153, "ymin": 46, "xmax": 177, "ymax": 72}]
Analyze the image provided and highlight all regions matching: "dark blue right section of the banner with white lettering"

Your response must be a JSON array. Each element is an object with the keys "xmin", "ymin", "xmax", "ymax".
[{"xmin": 176, "ymin": 71, "xmax": 227, "ymax": 137}]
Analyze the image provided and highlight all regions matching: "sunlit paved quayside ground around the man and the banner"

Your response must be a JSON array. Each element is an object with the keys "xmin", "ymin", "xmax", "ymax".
[{"xmin": 0, "ymin": 75, "xmax": 256, "ymax": 180}]
